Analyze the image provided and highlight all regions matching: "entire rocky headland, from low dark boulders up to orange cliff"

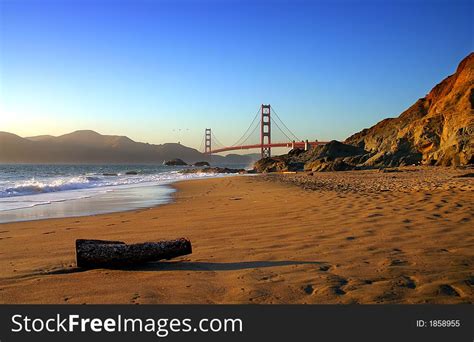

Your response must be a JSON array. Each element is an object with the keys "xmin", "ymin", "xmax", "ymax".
[{"xmin": 254, "ymin": 53, "xmax": 474, "ymax": 172}]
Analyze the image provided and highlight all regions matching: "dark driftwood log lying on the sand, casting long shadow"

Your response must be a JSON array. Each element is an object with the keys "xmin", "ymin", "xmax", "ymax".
[{"xmin": 76, "ymin": 238, "xmax": 192, "ymax": 268}]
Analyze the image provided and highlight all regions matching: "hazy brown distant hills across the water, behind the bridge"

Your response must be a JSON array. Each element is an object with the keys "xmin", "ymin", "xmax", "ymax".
[{"xmin": 0, "ymin": 130, "xmax": 260, "ymax": 164}]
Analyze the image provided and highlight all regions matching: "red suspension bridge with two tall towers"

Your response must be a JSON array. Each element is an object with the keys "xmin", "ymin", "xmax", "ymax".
[{"xmin": 200, "ymin": 104, "xmax": 327, "ymax": 158}]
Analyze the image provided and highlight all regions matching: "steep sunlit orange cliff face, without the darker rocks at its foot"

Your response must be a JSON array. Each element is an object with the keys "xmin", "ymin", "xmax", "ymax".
[{"xmin": 345, "ymin": 53, "xmax": 474, "ymax": 166}]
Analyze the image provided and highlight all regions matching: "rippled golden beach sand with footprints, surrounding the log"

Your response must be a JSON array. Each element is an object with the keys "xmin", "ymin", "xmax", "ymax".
[{"xmin": 0, "ymin": 168, "xmax": 474, "ymax": 304}]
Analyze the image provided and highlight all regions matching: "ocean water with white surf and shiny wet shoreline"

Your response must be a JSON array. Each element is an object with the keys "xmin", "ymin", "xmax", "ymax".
[{"xmin": 0, "ymin": 164, "xmax": 245, "ymax": 223}]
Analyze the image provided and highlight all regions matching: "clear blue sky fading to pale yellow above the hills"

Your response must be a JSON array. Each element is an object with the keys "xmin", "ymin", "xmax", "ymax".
[{"xmin": 0, "ymin": 0, "xmax": 474, "ymax": 148}]
